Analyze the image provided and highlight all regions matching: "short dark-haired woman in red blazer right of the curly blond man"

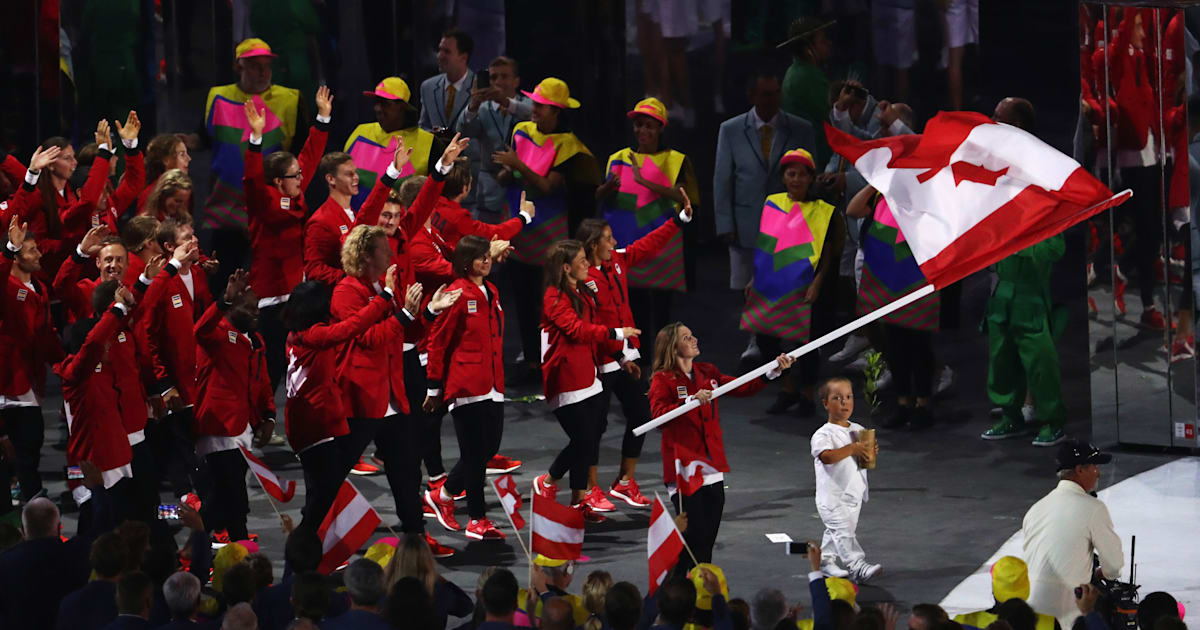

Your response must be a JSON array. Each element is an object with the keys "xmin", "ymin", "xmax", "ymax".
[{"xmin": 424, "ymin": 235, "xmax": 504, "ymax": 540}]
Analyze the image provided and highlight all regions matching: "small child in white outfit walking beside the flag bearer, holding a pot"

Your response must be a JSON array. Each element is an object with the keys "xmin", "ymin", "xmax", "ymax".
[{"xmin": 810, "ymin": 377, "xmax": 883, "ymax": 583}]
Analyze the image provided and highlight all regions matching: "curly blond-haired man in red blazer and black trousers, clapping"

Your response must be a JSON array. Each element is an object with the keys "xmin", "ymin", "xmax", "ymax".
[{"xmin": 330, "ymin": 223, "xmax": 466, "ymax": 556}]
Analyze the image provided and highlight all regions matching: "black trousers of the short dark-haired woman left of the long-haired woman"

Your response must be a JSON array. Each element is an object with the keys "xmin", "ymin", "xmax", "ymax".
[{"xmin": 444, "ymin": 401, "xmax": 504, "ymax": 520}]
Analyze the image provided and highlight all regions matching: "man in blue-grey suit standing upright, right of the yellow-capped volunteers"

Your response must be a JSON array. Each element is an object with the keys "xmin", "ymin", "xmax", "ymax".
[{"xmin": 713, "ymin": 71, "xmax": 816, "ymax": 289}]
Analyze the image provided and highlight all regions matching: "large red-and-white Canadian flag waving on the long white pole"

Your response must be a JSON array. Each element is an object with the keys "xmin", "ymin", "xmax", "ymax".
[{"xmin": 826, "ymin": 112, "xmax": 1133, "ymax": 288}]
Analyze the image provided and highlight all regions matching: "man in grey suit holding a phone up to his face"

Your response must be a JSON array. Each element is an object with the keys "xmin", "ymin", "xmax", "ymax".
[{"xmin": 458, "ymin": 56, "xmax": 533, "ymax": 223}]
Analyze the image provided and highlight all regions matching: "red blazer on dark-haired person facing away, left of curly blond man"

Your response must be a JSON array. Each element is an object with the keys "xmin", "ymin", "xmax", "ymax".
[{"xmin": 284, "ymin": 292, "xmax": 392, "ymax": 452}]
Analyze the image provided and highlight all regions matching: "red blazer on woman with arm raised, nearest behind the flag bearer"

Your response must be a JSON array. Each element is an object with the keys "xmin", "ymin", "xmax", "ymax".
[{"xmin": 588, "ymin": 217, "xmax": 679, "ymax": 365}]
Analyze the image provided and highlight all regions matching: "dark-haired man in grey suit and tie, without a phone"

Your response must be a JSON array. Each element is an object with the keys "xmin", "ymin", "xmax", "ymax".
[{"xmin": 418, "ymin": 29, "xmax": 480, "ymax": 209}]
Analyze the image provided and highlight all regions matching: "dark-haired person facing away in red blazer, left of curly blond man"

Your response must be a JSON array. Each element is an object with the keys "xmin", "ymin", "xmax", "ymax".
[{"xmin": 283, "ymin": 266, "xmax": 416, "ymax": 530}]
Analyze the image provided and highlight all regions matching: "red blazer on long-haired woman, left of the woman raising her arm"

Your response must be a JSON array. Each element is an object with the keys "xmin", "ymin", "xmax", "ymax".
[{"xmin": 540, "ymin": 287, "xmax": 617, "ymax": 409}]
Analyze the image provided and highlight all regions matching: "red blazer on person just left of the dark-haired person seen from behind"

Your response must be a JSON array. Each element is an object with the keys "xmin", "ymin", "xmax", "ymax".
[{"xmin": 192, "ymin": 304, "xmax": 275, "ymax": 437}]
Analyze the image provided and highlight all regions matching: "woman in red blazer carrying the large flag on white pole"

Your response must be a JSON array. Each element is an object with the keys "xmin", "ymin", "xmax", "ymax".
[{"xmin": 649, "ymin": 322, "xmax": 794, "ymax": 574}]
